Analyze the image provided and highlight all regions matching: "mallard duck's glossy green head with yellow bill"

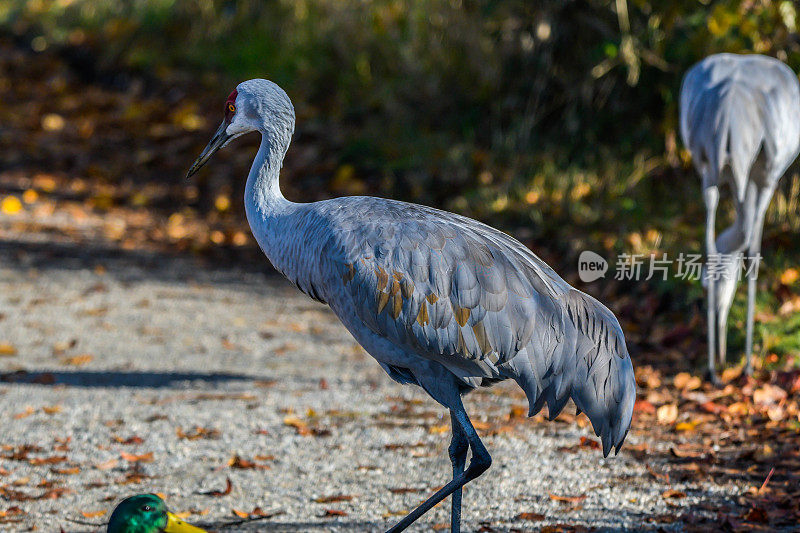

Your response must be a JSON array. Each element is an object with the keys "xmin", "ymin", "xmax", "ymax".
[{"xmin": 108, "ymin": 494, "xmax": 204, "ymax": 533}]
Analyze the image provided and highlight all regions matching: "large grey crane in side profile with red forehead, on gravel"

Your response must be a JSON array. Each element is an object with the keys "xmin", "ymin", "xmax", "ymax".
[{"xmin": 188, "ymin": 80, "xmax": 636, "ymax": 532}]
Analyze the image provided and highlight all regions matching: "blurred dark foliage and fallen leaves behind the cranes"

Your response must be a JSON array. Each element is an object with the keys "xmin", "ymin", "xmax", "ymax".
[{"xmin": 0, "ymin": 0, "xmax": 800, "ymax": 366}]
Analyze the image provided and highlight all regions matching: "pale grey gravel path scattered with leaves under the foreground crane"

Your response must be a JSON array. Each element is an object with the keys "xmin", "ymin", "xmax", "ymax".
[{"xmin": 0, "ymin": 234, "xmax": 743, "ymax": 531}]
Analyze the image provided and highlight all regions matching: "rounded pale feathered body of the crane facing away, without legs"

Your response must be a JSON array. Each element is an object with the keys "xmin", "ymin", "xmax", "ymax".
[{"xmin": 680, "ymin": 54, "xmax": 800, "ymax": 193}]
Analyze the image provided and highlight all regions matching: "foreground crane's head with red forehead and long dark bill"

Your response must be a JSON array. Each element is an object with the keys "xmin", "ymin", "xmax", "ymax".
[{"xmin": 186, "ymin": 79, "xmax": 294, "ymax": 178}]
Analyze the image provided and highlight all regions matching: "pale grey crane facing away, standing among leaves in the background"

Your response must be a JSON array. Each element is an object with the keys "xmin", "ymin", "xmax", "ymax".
[{"xmin": 680, "ymin": 54, "xmax": 800, "ymax": 381}]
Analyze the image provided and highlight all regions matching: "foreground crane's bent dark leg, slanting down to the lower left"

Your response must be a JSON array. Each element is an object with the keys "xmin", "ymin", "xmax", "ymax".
[{"xmin": 387, "ymin": 398, "xmax": 492, "ymax": 533}]
